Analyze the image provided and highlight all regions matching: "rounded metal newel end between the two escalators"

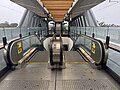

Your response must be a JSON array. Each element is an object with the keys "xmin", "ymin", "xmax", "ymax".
[{"xmin": 49, "ymin": 35, "xmax": 65, "ymax": 69}]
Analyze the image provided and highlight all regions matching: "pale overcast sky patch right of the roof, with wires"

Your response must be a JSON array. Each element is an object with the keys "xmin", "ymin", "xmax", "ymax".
[{"xmin": 92, "ymin": 0, "xmax": 120, "ymax": 25}]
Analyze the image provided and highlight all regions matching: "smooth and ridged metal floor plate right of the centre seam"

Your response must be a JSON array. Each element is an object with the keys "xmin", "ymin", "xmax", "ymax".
[{"xmin": 56, "ymin": 64, "xmax": 120, "ymax": 90}]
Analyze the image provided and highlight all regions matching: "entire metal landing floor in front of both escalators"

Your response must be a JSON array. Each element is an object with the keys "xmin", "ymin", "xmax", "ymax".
[{"xmin": 0, "ymin": 52, "xmax": 120, "ymax": 90}]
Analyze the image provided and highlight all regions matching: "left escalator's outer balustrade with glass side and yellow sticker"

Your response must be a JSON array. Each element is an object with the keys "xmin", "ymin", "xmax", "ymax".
[{"xmin": 4, "ymin": 35, "xmax": 41, "ymax": 66}]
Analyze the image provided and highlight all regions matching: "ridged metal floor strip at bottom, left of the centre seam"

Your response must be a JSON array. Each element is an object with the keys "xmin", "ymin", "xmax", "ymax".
[{"xmin": 0, "ymin": 80, "xmax": 50, "ymax": 90}]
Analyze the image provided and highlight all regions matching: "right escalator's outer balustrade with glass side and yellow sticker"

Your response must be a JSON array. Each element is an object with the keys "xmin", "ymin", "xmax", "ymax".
[{"xmin": 74, "ymin": 34, "xmax": 107, "ymax": 65}]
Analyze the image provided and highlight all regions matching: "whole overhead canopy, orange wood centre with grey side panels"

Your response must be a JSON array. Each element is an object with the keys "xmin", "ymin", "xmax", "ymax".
[{"xmin": 11, "ymin": 0, "xmax": 104, "ymax": 22}]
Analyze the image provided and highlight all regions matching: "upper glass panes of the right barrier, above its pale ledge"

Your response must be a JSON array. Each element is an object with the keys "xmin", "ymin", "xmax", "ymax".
[{"xmin": 70, "ymin": 27, "xmax": 120, "ymax": 46}]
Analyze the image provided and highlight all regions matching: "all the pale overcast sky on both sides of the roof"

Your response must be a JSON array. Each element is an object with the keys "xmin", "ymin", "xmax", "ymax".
[{"xmin": 0, "ymin": 0, "xmax": 120, "ymax": 25}]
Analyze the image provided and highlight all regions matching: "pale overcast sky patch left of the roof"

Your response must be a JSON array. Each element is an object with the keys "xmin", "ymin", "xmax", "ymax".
[{"xmin": 0, "ymin": 0, "xmax": 25, "ymax": 23}]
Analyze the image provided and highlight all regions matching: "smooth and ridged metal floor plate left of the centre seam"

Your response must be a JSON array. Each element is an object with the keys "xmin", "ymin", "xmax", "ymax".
[{"xmin": 0, "ymin": 65, "xmax": 55, "ymax": 90}]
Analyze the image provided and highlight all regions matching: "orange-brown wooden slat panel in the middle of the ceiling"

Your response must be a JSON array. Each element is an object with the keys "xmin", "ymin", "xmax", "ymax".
[{"xmin": 41, "ymin": 0, "xmax": 74, "ymax": 21}]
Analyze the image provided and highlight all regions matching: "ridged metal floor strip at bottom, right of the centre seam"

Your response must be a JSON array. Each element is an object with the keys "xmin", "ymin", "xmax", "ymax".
[{"xmin": 57, "ymin": 79, "xmax": 118, "ymax": 90}]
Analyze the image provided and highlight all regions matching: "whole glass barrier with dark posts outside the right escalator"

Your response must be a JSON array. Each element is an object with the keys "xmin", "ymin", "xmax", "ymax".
[{"xmin": 70, "ymin": 27, "xmax": 120, "ymax": 82}]
